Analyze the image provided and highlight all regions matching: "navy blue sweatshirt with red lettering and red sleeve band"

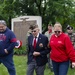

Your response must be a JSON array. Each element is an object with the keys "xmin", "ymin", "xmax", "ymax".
[{"xmin": 0, "ymin": 28, "xmax": 16, "ymax": 57}]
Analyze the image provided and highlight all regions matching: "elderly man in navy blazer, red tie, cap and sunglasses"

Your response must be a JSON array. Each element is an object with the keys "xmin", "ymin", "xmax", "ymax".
[{"xmin": 27, "ymin": 25, "xmax": 49, "ymax": 75}]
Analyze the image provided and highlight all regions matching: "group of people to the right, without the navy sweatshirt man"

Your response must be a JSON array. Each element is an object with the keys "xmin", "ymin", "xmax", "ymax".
[{"xmin": 27, "ymin": 22, "xmax": 75, "ymax": 75}]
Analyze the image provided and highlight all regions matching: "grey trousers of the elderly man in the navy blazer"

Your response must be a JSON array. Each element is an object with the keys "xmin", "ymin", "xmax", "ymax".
[{"xmin": 27, "ymin": 60, "xmax": 45, "ymax": 75}]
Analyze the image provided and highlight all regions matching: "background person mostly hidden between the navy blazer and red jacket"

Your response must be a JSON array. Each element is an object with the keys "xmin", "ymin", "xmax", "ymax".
[{"xmin": 45, "ymin": 24, "xmax": 53, "ymax": 71}]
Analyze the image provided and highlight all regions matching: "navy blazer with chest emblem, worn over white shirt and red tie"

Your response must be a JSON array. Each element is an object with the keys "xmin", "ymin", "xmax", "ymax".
[{"xmin": 28, "ymin": 34, "xmax": 50, "ymax": 66}]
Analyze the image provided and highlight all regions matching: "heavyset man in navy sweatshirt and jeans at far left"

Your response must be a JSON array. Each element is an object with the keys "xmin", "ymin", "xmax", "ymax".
[{"xmin": 0, "ymin": 20, "xmax": 16, "ymax": 75}]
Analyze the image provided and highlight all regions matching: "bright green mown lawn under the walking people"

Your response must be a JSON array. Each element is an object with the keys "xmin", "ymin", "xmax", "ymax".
[{"xmin": 0, "ymin": 55, "xmax": 75, "ymax": 75}]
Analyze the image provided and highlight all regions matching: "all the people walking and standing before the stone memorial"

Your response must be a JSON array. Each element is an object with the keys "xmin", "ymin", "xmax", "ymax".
[{"xmin": 0, "ymin": 20, "xmax": 75, "ymax": 75}]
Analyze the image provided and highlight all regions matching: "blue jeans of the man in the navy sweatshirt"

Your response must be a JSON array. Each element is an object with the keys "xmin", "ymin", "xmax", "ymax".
[{"xmin": 0, "ymin": 55, "xmax": 16, "ymax": 75}]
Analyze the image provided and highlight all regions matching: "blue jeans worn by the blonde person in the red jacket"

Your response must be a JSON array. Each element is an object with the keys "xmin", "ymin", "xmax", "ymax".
[{"xmin": 52, "ymin": 61, "xmax": 69, "ymax": 75}]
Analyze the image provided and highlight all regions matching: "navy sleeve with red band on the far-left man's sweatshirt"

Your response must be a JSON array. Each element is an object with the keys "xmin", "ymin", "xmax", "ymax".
[{"xmin": 7, "ymin": 31, "xmax": 17, "ymax": 52}]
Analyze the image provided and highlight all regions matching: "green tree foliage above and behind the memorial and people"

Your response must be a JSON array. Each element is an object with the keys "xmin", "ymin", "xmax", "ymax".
[{"xmin": 0, "ymin": 0, "xmax": 75, "ymax": 31}]
